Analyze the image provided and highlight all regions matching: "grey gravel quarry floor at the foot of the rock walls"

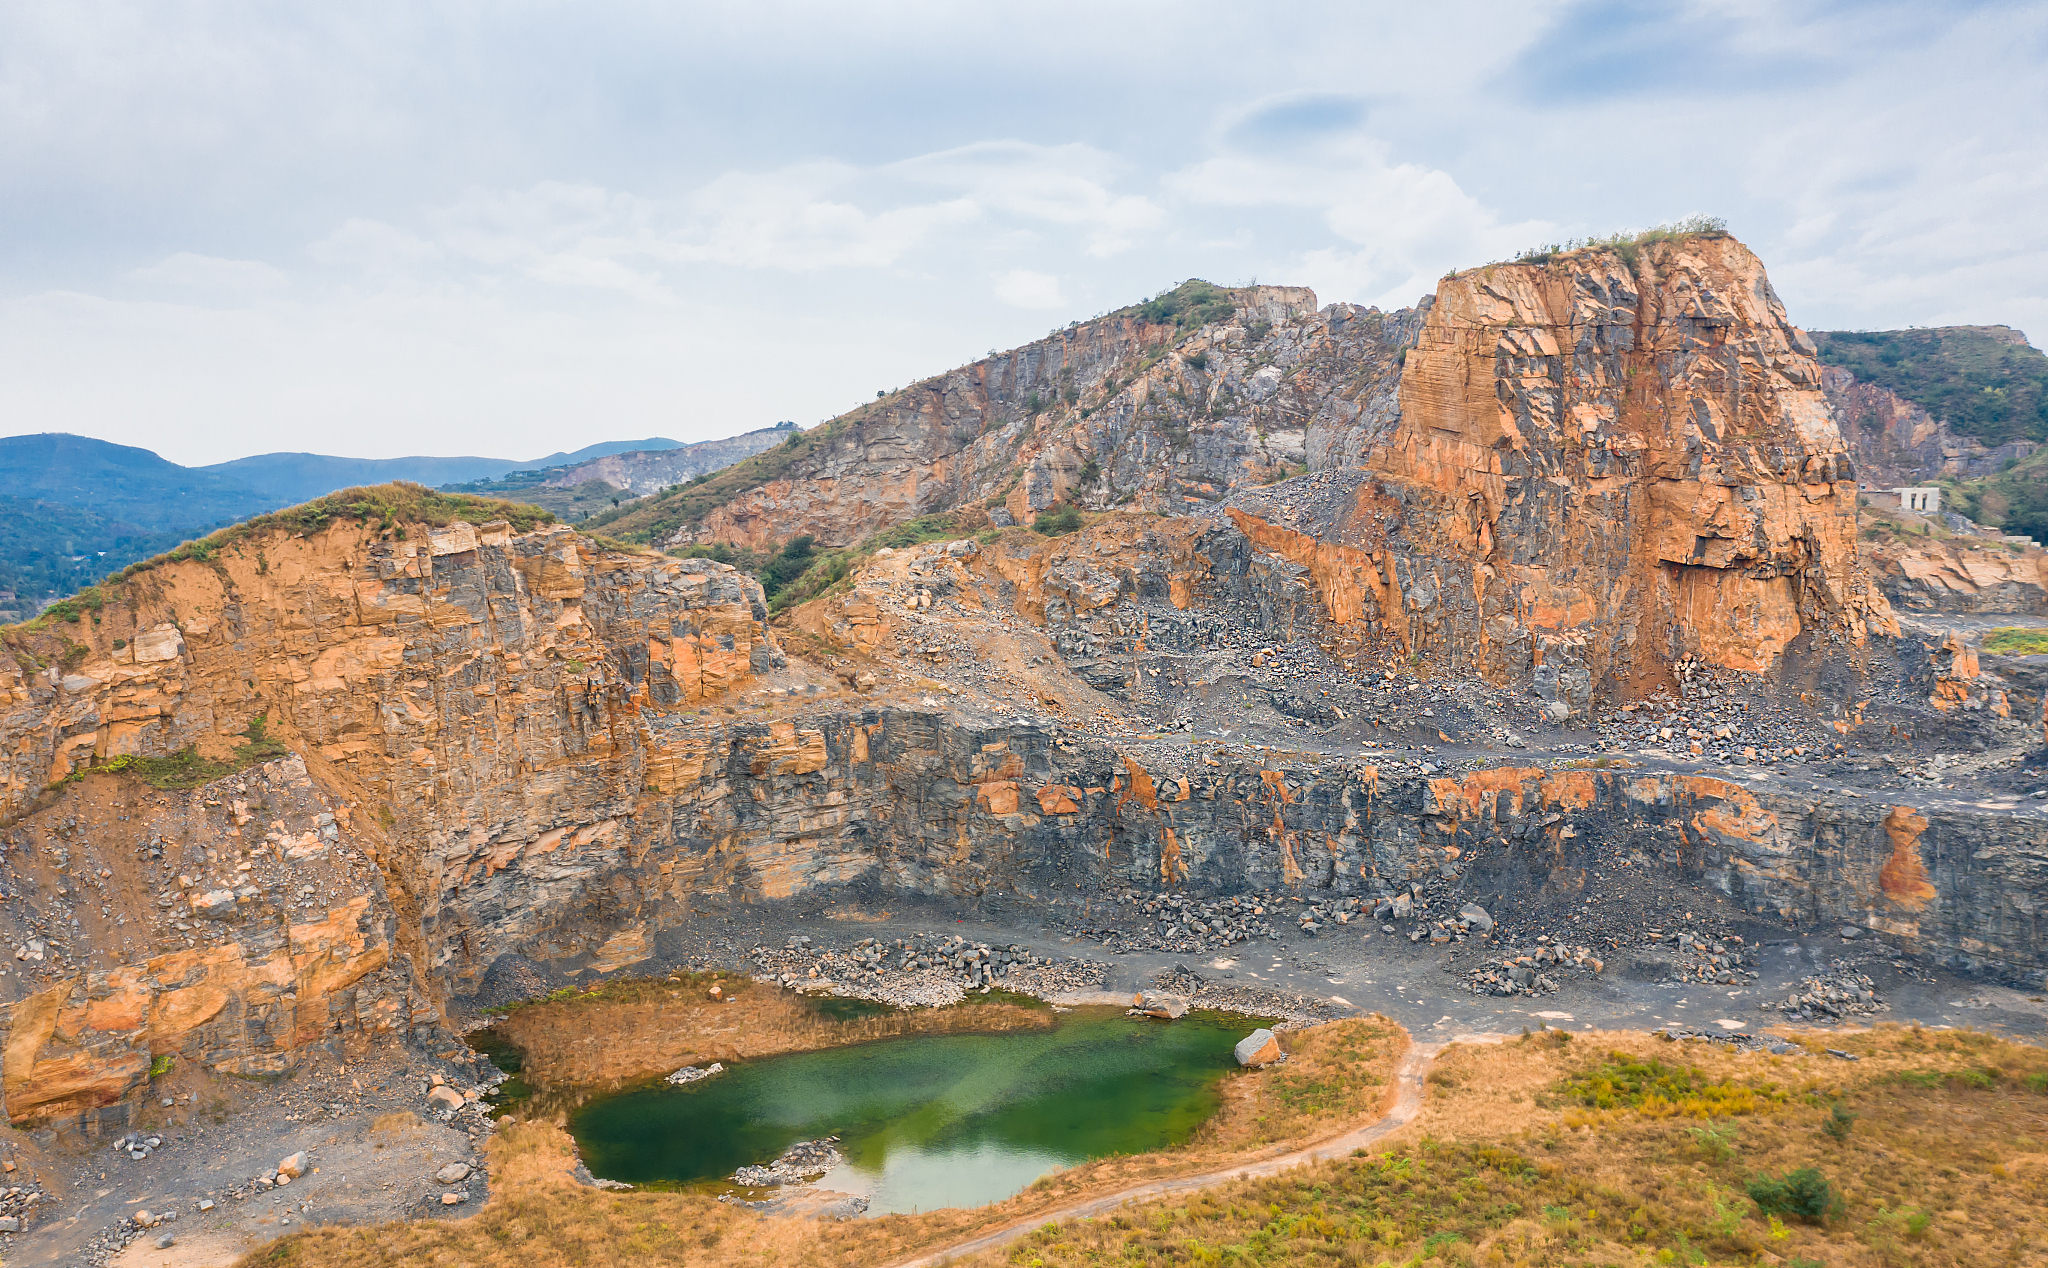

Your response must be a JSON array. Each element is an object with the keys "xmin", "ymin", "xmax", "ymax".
[{"xmin": 6, "ymin": 895, "xmax": 2048, "ymax": 1268}]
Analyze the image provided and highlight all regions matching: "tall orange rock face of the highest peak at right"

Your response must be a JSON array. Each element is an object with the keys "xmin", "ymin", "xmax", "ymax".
[{"xmin": 1231, "ymin": 238, "xmax": 1896, "ymax": 711}]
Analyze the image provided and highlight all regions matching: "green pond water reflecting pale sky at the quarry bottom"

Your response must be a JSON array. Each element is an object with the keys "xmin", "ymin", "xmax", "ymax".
[{"xmin": 569, "ymin": 1008, "xmax": 1260, "ymax": 1215}]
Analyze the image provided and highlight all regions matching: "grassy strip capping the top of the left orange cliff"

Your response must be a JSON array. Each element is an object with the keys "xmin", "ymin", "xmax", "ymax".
[{"xmin": 8, "ymin": 479, "xmax": 555, "ymax": 631}]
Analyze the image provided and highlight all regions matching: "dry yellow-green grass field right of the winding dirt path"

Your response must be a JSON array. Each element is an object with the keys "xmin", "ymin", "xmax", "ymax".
[{"xmin": 950, "ymin": 1026, "xmax": 2048, "ymax": 1268}]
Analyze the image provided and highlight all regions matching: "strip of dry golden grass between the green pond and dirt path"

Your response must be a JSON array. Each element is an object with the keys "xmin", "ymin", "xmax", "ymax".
[{"xmin": 228, "ymin": 1020, "xmax": 1405, "ymax": 1268}]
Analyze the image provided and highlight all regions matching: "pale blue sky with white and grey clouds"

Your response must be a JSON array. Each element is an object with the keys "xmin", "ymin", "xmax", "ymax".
[{"xmin": 0, "ymin": 0, "xmax": 2048, "ymax": 465}]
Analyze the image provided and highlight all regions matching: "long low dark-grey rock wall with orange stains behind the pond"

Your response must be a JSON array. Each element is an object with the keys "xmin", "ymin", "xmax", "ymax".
[{"xmin": 419, "ymin": 709, "xmax": 2048, "ymax": 989}]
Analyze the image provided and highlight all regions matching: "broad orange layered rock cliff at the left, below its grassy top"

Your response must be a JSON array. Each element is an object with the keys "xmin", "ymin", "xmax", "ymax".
[{"xmin": 0, "ymin": 520, "xmax": 782, "ymax": 1118}]
